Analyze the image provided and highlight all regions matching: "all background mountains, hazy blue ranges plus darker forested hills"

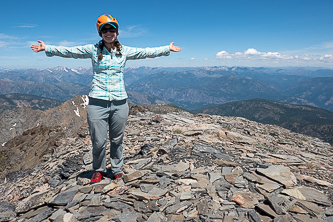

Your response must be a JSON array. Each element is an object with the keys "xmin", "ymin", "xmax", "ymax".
[{"xmin": 0, "ymin": 67, "xmax": 333, "ymax": 145}]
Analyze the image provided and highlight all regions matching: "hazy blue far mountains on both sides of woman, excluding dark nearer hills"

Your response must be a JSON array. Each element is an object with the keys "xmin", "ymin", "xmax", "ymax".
[{"xmin": 0, "ymin": 67, "xmax": 333, "ymax": 111}]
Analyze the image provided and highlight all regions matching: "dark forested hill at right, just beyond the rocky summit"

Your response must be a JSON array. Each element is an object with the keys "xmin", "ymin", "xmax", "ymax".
[{"xmin": 196, "ymin": 99, "xmax": 333, "ymax": 145}]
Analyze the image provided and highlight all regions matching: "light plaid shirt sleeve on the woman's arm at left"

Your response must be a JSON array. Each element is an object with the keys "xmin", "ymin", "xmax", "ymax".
[{"xmin": 45, "ymin": 45, "xmax": 95, "ymax": 59}]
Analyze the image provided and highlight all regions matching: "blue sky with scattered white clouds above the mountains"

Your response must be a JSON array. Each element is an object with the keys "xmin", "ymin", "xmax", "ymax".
[{"xmin": 0, "ymin": 0, "xmax": 333, "ymax": 69}]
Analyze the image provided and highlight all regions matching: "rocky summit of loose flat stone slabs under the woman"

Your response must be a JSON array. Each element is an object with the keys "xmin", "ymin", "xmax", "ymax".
[{"xmin": 0, "ymin": 98, "xmax": 333, "ymax": 222}]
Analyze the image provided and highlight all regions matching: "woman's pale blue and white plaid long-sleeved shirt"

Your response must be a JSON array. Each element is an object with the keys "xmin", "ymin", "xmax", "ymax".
[{"xmin": 45, "ymin": 44, "xmax": 170, "ymax": 101}]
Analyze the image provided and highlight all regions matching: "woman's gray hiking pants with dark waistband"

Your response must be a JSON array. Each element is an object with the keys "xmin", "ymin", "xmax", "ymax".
[{"xmin": 87, "ymin": 98, "xmax": 129, "ymax": 175}]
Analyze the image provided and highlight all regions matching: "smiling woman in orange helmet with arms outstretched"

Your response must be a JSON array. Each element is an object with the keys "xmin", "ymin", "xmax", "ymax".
[{"xmin": 31, "ymin": 15, "xmax": 181, "ymax": 183}]
